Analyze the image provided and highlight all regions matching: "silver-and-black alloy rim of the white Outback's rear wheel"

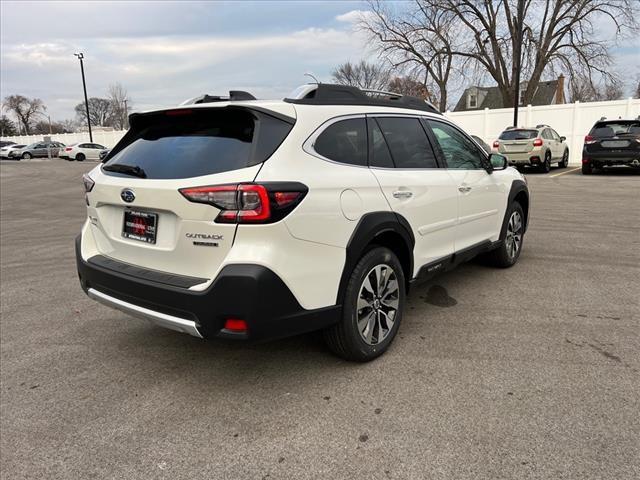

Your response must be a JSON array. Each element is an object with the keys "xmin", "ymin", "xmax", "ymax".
[{"xmin": 356, "ymin": 264, "xmax": 400, "ymax": 345}]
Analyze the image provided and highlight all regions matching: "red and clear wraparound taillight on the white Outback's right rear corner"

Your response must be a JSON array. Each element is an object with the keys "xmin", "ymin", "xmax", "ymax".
[{"xmin": 180, "ymin": 182, "xmax": 308, "ymax": 223}]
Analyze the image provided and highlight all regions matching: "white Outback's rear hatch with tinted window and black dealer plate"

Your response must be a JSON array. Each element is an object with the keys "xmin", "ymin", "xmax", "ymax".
[{"xmin": 88, "ymin": 104, "xmax": 295, "ymax": 280}]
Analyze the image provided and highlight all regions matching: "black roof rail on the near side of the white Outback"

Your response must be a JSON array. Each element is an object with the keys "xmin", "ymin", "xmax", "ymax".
[{"xmin": 284, "ymin": 83, "xmax": 441, "ymax": 114}]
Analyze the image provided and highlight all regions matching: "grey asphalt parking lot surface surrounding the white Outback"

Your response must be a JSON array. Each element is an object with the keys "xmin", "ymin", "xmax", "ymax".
[{"xmin": 0, "ymin": 160, "xmax": 640, "ymax": 480}]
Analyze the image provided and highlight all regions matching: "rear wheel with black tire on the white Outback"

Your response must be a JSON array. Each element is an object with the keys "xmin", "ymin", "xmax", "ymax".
[{"xmin": 324, "ymin": 247, "xmax": 406, "ymax": 362}]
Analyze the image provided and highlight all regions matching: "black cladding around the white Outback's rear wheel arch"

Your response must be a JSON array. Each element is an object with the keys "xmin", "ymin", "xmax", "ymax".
[{"xmin": 336, "ymin": 212, "xmax": 415, "ymax": 305}]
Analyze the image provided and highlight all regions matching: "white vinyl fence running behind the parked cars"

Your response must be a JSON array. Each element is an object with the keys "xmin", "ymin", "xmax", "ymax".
[{"xmin": 2, "ymin": 98, "xmax": 640, "ymax": 164}]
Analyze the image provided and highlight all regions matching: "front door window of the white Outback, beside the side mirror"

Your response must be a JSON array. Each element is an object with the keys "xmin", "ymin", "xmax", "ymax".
[{"xmin": 427, "ymin": 120, "xmax": 485, "ymax": 170}]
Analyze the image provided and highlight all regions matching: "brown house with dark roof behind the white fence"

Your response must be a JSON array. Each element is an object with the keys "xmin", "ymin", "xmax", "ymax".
[{"xmin": 453, "ymin": 75, "xmax": 565, "ymax": 112}]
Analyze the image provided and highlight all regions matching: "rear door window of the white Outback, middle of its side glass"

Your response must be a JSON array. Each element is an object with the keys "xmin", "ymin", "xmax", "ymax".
[{"xmin": 376, "ymin": 117, "xmax": 438, "ymax": 168}]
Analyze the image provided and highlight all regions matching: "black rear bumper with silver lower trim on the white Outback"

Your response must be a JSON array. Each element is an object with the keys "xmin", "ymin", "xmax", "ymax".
[{"xmin": 76, "ymin": 236, "xmax": 341, "ymax": 342}]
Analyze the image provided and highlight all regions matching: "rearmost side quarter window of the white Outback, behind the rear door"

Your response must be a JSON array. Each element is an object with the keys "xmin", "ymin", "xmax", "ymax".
[{"xmin": 313, "ymin": 118, "xmax": 367, "ymax": 166}]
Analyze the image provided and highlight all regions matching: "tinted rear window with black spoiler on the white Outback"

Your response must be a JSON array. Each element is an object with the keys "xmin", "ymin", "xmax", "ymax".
[{"xmin": 104, "ymin": 108, "xmax": 292, "ymax": 179}]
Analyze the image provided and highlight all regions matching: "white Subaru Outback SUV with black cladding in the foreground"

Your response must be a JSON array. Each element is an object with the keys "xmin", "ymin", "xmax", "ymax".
[{"xmin": 76, "ymin": 84, "xmax": 529, "ymax": 361}]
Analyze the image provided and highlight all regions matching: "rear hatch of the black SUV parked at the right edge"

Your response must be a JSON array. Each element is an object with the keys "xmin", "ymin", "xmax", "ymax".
[{"xmin": 585, "ymin": 120, "xmax": 640, "ymax": 156}]
